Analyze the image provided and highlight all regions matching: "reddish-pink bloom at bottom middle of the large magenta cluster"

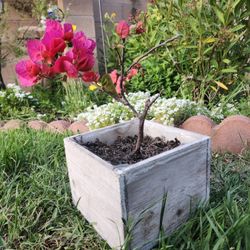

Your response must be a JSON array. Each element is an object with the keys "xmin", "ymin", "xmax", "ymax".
[{"xmin": 53, "ymin": 56, "xmax": 78, "ymax": 78}]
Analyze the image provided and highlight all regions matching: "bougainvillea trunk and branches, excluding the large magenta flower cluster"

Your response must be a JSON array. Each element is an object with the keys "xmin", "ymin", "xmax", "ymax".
[{"xmin": 93, "ymin": 20, "xmax": 179, "ymax": 154}]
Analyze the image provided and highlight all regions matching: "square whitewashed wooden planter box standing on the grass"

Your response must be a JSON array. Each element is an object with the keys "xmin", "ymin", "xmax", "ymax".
[{"xmin": 64, "ymin": 120, "xmax": 210, "ymax": 250}]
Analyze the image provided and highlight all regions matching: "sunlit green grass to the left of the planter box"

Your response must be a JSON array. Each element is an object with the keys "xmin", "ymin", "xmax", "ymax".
[{"xmin": 0, "ymin": 130, "xmax": 108, "ymax": 250}]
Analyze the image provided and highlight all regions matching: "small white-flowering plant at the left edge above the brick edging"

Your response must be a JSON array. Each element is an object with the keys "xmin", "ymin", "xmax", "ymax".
[{"xmin": 0, "ymin": 83, "xmax": 39, "ymax": 120}]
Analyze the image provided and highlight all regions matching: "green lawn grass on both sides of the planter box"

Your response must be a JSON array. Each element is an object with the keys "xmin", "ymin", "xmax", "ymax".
[{"xmin": 0, "ymin": 129, "xmax": 250, "ymax": 250}]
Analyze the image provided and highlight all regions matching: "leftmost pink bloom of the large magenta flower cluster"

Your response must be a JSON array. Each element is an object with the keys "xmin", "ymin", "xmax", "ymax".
[{"xmin": 16, "ymin": 60, "xmax": 41, "ymax": 87}]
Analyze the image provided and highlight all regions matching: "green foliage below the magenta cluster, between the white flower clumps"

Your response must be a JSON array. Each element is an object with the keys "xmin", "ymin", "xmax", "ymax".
[{"xmin": 28, "ymin": 77, "xmax": 110, "ymax": 121}]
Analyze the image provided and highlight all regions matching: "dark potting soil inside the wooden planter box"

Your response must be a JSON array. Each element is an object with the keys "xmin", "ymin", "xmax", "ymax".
[{"xmin": 78, "ymin": 135, "xmax": 181, "ymax": 165}]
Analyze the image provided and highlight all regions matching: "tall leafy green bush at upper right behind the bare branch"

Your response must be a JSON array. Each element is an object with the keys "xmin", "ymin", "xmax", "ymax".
[{"xmin": 106, "ymin": 0, "xmax": 250, "ymax": 102}]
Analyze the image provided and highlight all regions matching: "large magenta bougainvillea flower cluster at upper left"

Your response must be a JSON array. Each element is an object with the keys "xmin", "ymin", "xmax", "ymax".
[{"xmin": 16, "ymin": 20, "xmax": 96, "ymax": 86}]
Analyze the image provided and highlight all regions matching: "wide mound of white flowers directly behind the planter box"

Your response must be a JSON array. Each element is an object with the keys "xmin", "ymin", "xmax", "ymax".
[{"xmin": 76, "ymin": 92, "xmax": 239, "ymax": 129}]
